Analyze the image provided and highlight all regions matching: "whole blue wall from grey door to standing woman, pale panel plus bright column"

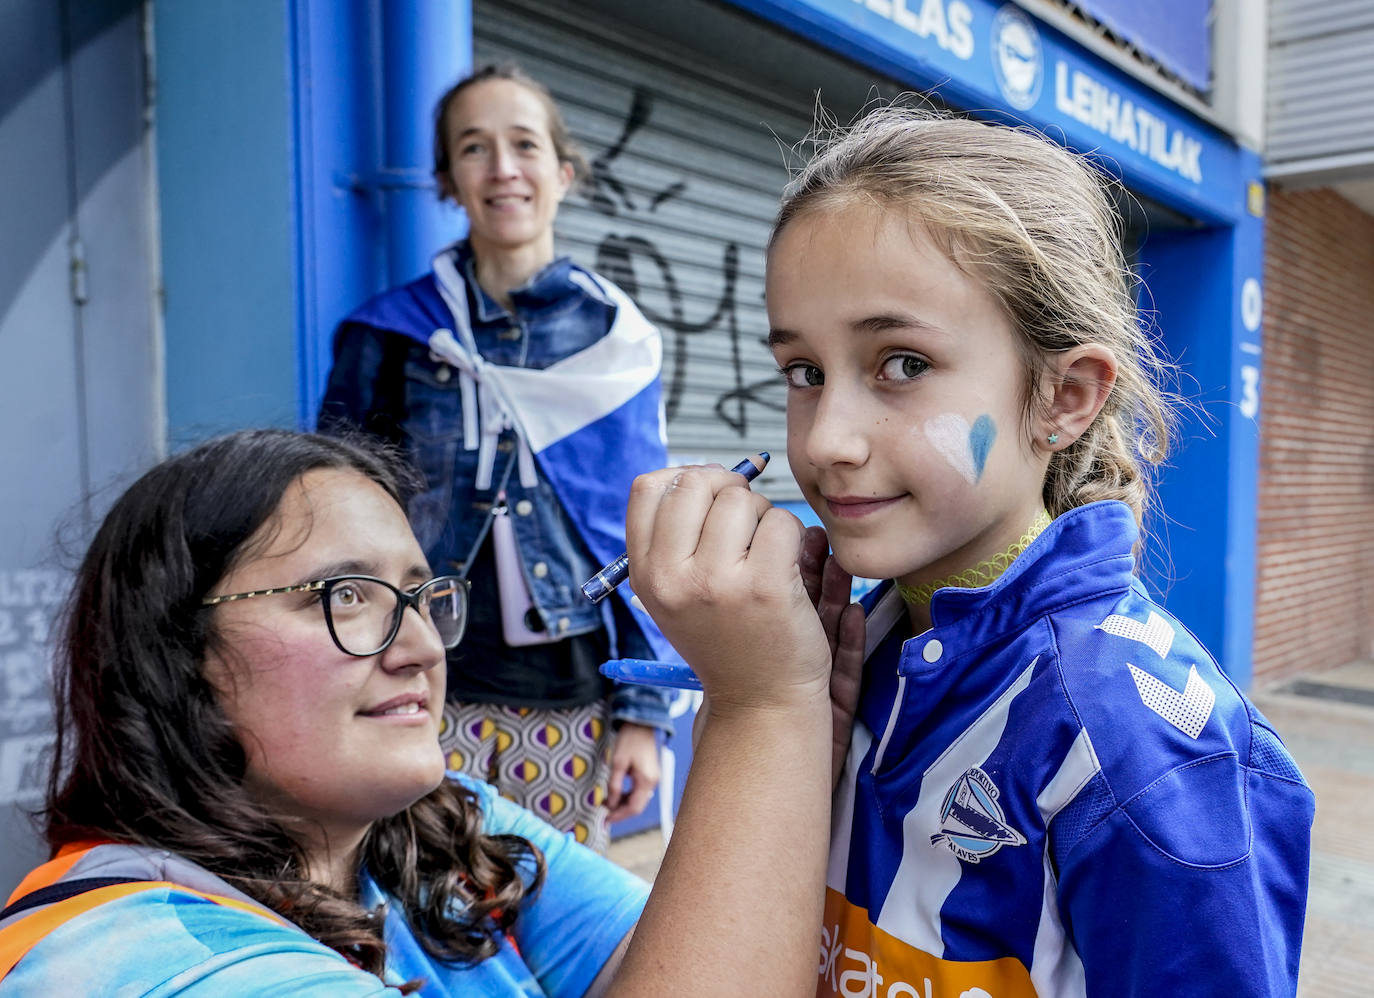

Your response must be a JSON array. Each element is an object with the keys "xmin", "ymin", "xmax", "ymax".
[{"xmin": 154, "ymin": 0, "xmax": 471, "ymax": 445}]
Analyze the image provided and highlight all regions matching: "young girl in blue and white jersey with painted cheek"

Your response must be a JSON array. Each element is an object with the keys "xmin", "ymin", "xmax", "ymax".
[{"xmin": 767, "ymin": 109, "xmax": 1314, "ymax": 998}]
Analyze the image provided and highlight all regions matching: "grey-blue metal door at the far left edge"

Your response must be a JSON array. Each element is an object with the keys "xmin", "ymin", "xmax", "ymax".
[{"xmin": 0, "ymin": 0, "xmax": 162, "ymax": 896}]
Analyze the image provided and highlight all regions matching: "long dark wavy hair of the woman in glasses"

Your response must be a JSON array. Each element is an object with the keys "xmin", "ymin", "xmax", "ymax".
[{"xmin": 41, "ymin": 430, "xmax": 544, "ymax": 984}]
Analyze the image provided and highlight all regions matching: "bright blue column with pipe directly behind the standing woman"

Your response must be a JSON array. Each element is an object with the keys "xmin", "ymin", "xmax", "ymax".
[{"xmin": 291, "ymin": 0, "xmax": 473, "ymax": 428}]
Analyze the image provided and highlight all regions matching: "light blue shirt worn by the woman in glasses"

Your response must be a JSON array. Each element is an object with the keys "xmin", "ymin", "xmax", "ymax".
[{"xmin": 0, "ymin": 774, "xmax": 649, "ymax": 998}]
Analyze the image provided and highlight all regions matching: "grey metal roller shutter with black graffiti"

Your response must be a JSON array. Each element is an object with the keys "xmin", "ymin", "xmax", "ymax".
[{"xmin": 474, "ymin": 1, "xmax": 811, "ymax": 499}]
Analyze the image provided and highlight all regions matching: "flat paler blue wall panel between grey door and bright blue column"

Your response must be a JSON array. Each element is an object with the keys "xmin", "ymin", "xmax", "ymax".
[{"xmin": 153, "ymin": 0, "xmax": 298, "ymax": 447}]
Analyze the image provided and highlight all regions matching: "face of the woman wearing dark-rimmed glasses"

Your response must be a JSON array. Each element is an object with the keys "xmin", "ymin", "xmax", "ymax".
[{"xmin": 206, "ymin": 469, "xmax": 445, "ymax": 848}]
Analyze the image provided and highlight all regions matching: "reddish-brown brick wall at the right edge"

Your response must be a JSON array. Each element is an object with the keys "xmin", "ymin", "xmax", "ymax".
[{"xmin": 1254, "ymin": 188, "xmax": 1374, "ymax": 685}]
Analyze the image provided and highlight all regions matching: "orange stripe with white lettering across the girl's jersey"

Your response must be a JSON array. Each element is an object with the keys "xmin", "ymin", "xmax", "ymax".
[{"xmin": 816, "ymin": 888, "xmax": 1036, "ymax": 998}]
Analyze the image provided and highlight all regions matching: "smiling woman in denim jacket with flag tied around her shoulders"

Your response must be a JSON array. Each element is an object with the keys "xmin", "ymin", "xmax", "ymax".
[{"xmin": 320, "ymin": 65, "xmax": 671, "ymax": 851}]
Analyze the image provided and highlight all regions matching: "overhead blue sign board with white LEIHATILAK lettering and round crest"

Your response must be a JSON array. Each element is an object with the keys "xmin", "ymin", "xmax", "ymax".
[{"xmin": 734, "ymin": 0, "xmax": 1248, "ymax": 224}]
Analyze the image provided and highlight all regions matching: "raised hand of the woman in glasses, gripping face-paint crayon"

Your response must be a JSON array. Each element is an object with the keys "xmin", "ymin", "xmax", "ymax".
[{"xmin": 615, "ymin": 462, "xmax": 831, "ymax": 712}]
